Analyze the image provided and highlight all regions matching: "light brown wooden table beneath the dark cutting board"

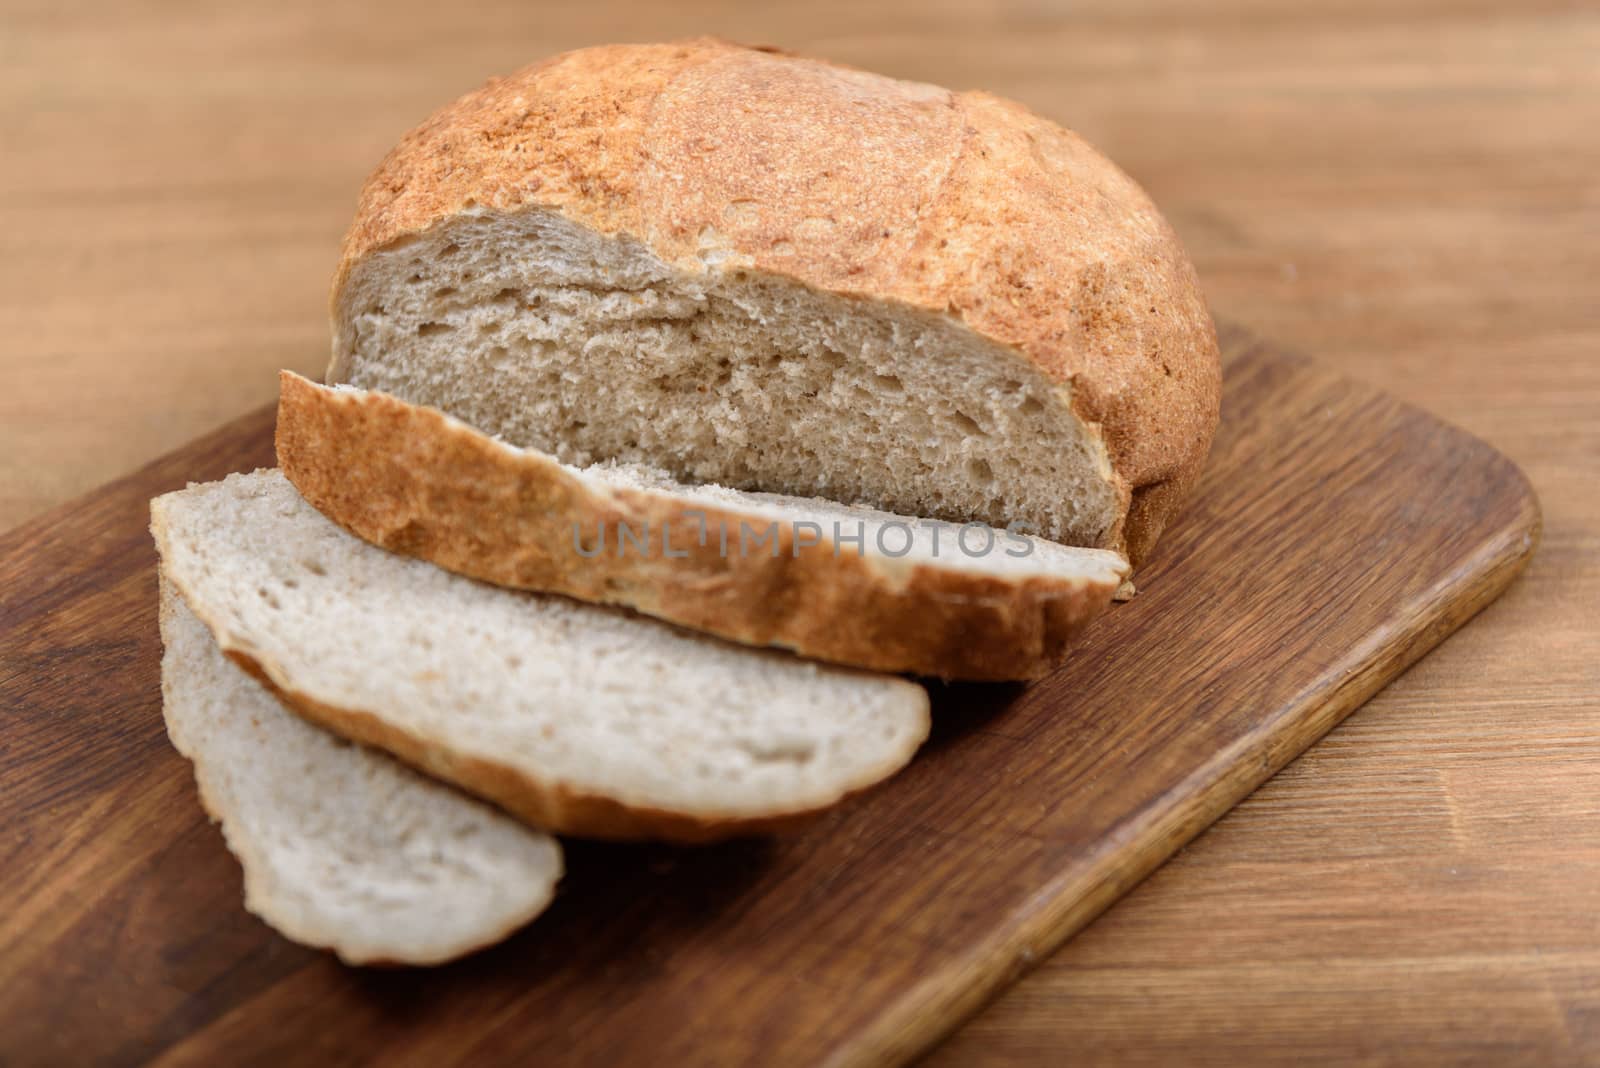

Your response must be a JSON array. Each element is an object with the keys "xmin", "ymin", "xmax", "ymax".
[{"xmin": 0, "ymin": 0, "xmax": 1600, "ymax": 1065}]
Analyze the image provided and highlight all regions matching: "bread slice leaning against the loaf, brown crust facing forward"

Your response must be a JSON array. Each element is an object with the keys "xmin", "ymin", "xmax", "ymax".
[{"xmin": 278, "ymin": 371, "xmax": 1128, "ymax": 679}]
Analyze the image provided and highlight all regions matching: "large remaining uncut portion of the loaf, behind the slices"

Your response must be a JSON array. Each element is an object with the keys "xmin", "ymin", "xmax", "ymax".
[{"xmin": 328, "ymin": 40, "xmax": 1221, "ymax": 563}]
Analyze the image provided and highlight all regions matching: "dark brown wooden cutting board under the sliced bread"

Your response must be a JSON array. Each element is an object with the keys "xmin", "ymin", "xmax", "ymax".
[{"xmin": 0, "ymin": 333, "xmax": 1539, "ymax": 1068}]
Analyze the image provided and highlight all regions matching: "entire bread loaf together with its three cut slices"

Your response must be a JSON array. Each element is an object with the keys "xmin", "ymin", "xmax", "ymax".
[{"xmin": 152, "ymin": 40, "xmax": 1219, "ymax": 962}]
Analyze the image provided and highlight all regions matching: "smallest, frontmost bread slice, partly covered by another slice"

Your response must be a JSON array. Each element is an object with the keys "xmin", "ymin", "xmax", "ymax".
[{"xmin": 162, "ymin": 579, "xmax": 562, "ymax": 964}]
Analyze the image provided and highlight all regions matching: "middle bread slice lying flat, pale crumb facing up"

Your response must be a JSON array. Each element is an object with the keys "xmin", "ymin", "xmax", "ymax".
[{"xmin": 150, "ymin": 470, "xmax": 928, "ymax": 841}]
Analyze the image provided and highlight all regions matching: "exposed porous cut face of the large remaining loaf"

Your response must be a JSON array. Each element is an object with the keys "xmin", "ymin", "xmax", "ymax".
[{"xmin": 330, "ymin": 211, "xmax": 1120, "ymax": 545}]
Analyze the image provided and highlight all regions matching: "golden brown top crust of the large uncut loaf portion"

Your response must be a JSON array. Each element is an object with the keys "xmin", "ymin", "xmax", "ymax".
[{"xmin": 334, "ymin": 38, "xmax": 1221, "ymax": 563}]
